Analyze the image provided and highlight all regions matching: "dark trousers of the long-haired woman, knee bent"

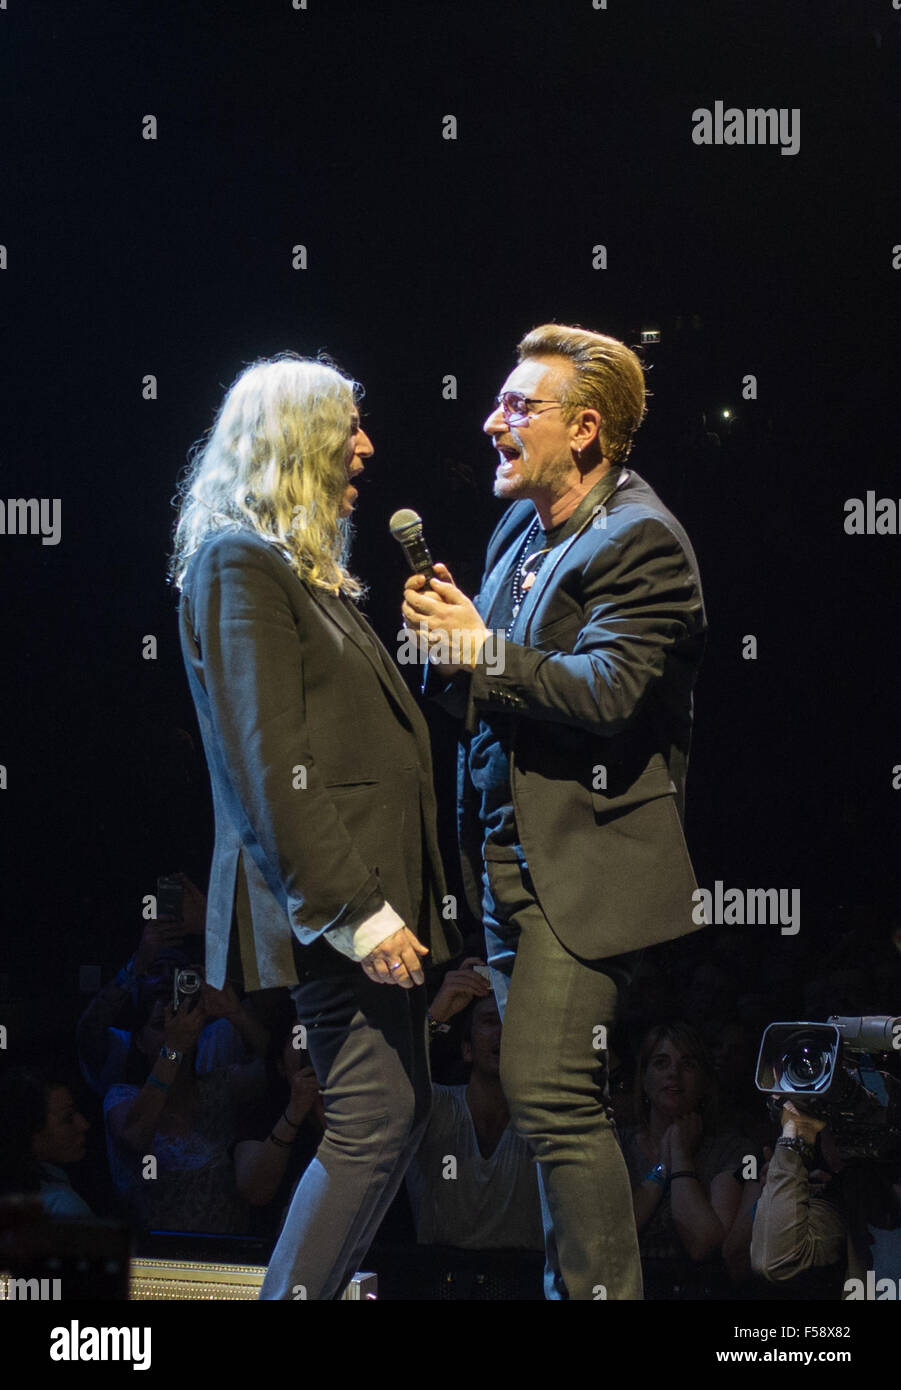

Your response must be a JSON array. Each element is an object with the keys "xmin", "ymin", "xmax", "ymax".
[{"xmin": 260, "ymin": 942, "xmax": 431, "ymax": 1300}]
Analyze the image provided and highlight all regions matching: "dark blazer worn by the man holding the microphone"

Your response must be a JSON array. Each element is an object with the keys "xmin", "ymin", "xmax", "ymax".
[{"xmin": 445, "ymin": 471, "xmax": 706, "ymax": 960}]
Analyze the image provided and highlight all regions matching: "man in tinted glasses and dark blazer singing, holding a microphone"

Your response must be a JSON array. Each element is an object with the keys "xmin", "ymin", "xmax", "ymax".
[{"xmin": 403, "ymin": 324, "xmax": 706, "ymax": 1300}]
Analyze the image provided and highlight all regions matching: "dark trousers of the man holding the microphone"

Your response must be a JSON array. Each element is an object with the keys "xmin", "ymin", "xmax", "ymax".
[{"xmin": 482, "ymin": 856, "xmax": 642, "ymax": 1300}]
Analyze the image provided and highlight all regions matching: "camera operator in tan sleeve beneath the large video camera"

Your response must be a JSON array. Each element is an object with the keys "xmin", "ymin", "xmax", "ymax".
[{"xmin": 751, "ymin": 1101, "xmax": 901, "ymax": 1297}]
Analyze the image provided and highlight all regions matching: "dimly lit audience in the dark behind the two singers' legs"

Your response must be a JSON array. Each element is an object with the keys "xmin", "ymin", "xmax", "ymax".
[{"xmin": 0, "ymin": 874, "xmax": 901, "ymax": 1300}]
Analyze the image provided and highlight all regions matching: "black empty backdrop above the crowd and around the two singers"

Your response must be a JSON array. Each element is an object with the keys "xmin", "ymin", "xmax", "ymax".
[{"xmin": 0, "ymin": 0, "xmax": 901, "ymax": 1262}]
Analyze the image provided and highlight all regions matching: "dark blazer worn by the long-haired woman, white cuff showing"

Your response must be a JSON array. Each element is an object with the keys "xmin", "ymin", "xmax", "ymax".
[{"xmin": 179, "ymin": 530, "xmax": 460, "ymax": 990}]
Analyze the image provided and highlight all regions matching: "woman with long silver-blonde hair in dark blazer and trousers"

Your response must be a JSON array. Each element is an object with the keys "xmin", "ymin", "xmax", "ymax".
[{"xmin": 172, "ymin": 353, "xmax": 459, "ymax": 1300}]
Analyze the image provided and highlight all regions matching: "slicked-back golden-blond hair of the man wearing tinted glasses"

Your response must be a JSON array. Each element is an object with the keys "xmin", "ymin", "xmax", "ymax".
[{"xmin": 517, "ymin": 324, "xmax": 647, "ymax": 463}]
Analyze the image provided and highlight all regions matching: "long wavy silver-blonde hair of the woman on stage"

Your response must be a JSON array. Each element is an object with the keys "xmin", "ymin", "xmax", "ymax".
[{"xmin": 168, "ymin": 352, "xmax": 363, "ymax": 598}]
